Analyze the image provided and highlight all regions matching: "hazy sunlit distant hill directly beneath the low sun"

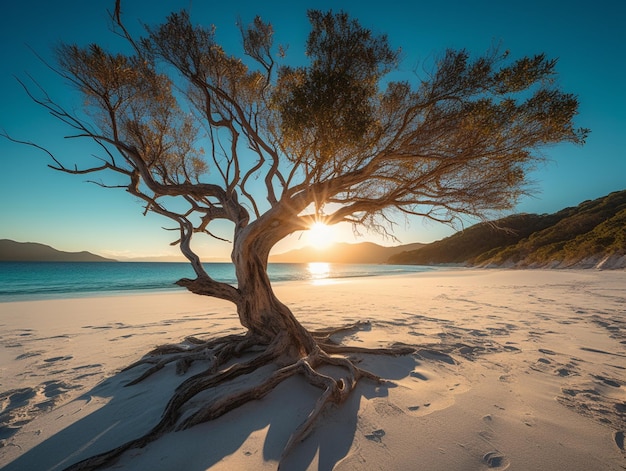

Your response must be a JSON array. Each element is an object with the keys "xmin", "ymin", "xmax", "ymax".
[{"xmin": 269, "ymin": 242, "xmax": 424, "ymax": 263}]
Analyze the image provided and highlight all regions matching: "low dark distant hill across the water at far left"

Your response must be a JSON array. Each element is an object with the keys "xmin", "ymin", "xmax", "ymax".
[{"xmin": 0, "ymin": 239, "xmax": 116, "ymax": 262}]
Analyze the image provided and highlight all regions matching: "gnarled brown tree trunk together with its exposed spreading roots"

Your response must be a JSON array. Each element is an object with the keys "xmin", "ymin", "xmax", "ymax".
[{"xmin": 61, "ymin": 218, "xmax": 415, "ymax": 471}]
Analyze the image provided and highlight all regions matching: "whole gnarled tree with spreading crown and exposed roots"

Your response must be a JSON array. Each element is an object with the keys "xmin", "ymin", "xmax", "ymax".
[{"xmin": 11, "ymin": 0, "xmax": 587, "ymax": 469}]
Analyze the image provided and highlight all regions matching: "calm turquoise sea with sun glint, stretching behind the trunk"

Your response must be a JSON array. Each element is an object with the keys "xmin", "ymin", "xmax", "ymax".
[{"xmin": 0, "ymin": 262, "xmax": 436, "ymax": 302}]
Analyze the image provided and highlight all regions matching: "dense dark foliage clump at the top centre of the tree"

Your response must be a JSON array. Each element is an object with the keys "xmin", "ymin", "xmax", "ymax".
[{"xmin": 275, "ymin": 10, "xmax": 398, "ymax": 162}]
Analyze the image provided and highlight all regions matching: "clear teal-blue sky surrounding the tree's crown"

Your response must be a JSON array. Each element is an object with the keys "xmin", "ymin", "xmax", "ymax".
[{"xmin": 0, "ymin": 0, "xmax": 626, "ymax": 257}]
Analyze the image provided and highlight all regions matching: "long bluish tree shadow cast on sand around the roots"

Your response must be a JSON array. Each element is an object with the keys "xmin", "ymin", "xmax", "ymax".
[{"xmin": 5, "ymin": 342, "xmax": 438, "ymax": 471}]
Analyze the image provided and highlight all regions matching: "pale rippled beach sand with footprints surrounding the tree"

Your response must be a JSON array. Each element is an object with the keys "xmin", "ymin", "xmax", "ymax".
[{"xmin": 0, "ymin": 269, "xmax": 626, "ymax": 471}]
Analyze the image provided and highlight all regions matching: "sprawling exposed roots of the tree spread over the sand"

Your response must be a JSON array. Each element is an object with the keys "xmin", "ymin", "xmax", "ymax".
[{"xmin": 66, "ymin": 322, "xmax": 415, "ymax": 471}]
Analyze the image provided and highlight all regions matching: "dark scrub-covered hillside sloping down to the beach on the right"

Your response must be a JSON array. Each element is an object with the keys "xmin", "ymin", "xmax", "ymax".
[{"xmin": 389, "ymin": 190, "xmax": 626, "ymax": 268}]
